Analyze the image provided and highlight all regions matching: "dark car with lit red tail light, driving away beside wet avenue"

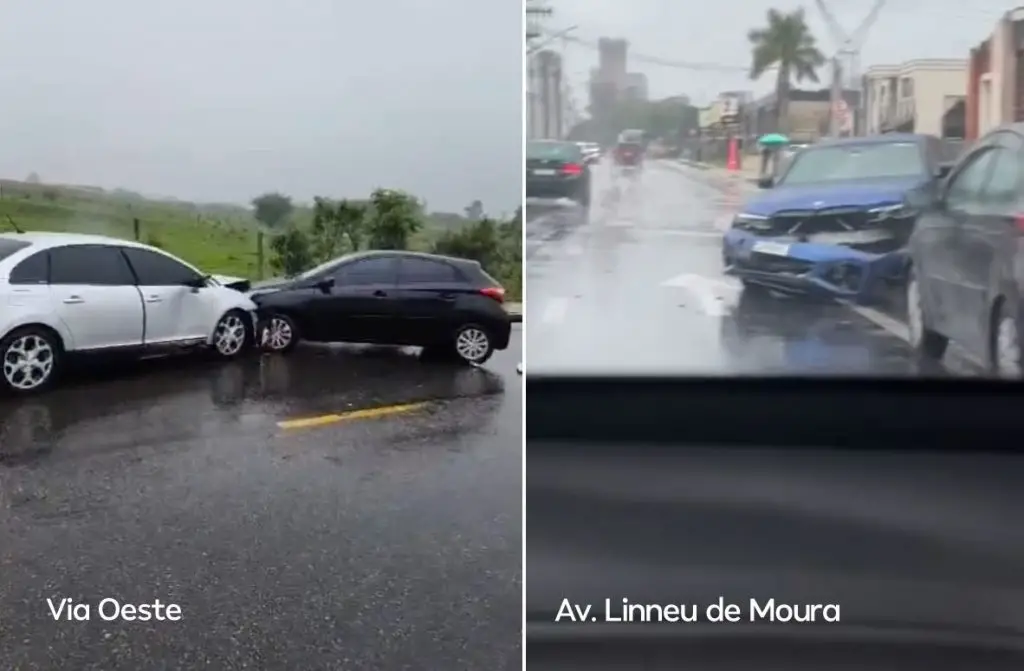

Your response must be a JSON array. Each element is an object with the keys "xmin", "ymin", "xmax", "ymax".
[{"xmin": 526, "ymin": 139, "xmax": 591, "ymax": 208}]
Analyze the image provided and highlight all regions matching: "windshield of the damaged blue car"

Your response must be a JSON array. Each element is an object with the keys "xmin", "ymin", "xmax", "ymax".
[{"xmin": 779, "ymin": 142, "xmax": 927, "ymax": 186}]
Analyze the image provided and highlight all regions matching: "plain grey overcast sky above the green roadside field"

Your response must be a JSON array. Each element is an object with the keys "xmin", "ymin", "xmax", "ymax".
[{"xmin": 0, "ymin": 0, "xmax": 522, "ymax": 213}]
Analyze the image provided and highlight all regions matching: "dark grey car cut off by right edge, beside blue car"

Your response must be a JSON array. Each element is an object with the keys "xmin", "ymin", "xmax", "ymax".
[{"xmin": 906, "ymin": 124, "xmax": 1024, "ymax": 378}]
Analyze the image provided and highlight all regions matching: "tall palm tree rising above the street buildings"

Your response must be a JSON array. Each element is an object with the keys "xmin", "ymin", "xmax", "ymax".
[{"xmin": 746, "ymin": 9, "xmax": 825, "ymax": 132}]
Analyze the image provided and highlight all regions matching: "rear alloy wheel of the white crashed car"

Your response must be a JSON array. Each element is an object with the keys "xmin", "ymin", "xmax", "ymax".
[{"xmin": 0, "ymin": 326, "xmax": 63, "ymax": 394}]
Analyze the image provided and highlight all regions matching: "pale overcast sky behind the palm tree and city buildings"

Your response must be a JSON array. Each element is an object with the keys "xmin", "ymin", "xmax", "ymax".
[{"xmin": 548, "ymin": 0, "xmax": 1011, "ymax": 104}]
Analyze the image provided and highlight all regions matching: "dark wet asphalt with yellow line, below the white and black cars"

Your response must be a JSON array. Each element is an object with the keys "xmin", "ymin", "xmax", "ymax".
[{"xmin": 0, "ymin": 327, "xmax": 522, "ymax": 671}]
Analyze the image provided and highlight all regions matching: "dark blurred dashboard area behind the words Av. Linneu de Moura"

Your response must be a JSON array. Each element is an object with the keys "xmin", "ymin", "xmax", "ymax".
[{"xmin": 525, "ymin": 376, "xmax": 1024, "ymax": 671}]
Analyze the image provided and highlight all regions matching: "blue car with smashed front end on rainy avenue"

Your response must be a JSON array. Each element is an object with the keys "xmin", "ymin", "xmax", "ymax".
[{"xmin": 722, "ymin": 134, "xmax": 949, "ymax": 302}]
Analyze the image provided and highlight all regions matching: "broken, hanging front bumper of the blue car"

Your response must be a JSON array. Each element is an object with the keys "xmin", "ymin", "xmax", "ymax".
[{"xmin": 723, "ymin": 226, "xmax": 909, "ymax": 303}]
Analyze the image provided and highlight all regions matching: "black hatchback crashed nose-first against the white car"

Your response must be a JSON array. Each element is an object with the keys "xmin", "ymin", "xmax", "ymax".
[{"xmin": 251, "ymin": 251, "xmax": 512, "ymax": 364}]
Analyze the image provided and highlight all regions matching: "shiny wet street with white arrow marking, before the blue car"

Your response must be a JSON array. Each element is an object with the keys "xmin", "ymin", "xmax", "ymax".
[{"xmin": 525, "ymin": 161, "xmax": 978, "ymax": 376}]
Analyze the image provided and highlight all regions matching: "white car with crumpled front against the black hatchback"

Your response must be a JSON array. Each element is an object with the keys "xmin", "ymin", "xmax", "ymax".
[{"xmin": 0, "ymin": 233, "xmax": 256, "ymax": 393}]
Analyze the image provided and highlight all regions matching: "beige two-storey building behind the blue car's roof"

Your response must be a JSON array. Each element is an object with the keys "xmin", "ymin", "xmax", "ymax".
[{"xmin": 861, "ymin": 58, "xmax": 968, "ymax": 139}]
